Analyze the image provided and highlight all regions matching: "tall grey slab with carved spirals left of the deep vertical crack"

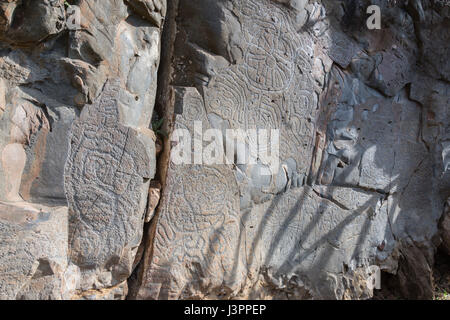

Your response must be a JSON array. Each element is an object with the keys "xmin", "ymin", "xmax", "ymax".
[{"xmin": 65, "ymin": 80, "xmax": 155, "ymax": 290}]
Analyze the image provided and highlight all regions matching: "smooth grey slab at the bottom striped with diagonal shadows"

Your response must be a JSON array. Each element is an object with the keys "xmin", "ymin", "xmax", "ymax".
[{"xmin": 242, "ymin": 187, "xmax": 393, "ymax": 299}]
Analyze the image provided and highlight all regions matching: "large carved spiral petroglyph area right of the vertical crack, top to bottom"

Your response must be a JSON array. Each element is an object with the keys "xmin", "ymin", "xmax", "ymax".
[{"xmin": 139, "ymin": 1, "xmax": 324, "ymax": 299}]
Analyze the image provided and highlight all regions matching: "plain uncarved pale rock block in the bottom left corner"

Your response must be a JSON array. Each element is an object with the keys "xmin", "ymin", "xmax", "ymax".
[{"xmin": 0, "ymin": 203, "xmax": 70, "ymax": 300}]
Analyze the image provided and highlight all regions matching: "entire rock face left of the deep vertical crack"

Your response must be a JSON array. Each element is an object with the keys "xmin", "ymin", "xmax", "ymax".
[{"xmin": 0, "ymin": 0, "xmax": 165, "ymax": 299}]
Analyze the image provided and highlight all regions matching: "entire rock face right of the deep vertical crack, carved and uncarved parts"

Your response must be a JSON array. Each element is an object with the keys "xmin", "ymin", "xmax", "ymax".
[{"xmin": 131, "ymin": 0, "xmax": 449, "ymax": 299}]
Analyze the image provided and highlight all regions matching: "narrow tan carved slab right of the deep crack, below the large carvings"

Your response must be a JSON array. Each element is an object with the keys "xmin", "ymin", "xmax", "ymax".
[{"xmin": 133, "ymin": 87, "xmax": 243, "ymax": 299}]
